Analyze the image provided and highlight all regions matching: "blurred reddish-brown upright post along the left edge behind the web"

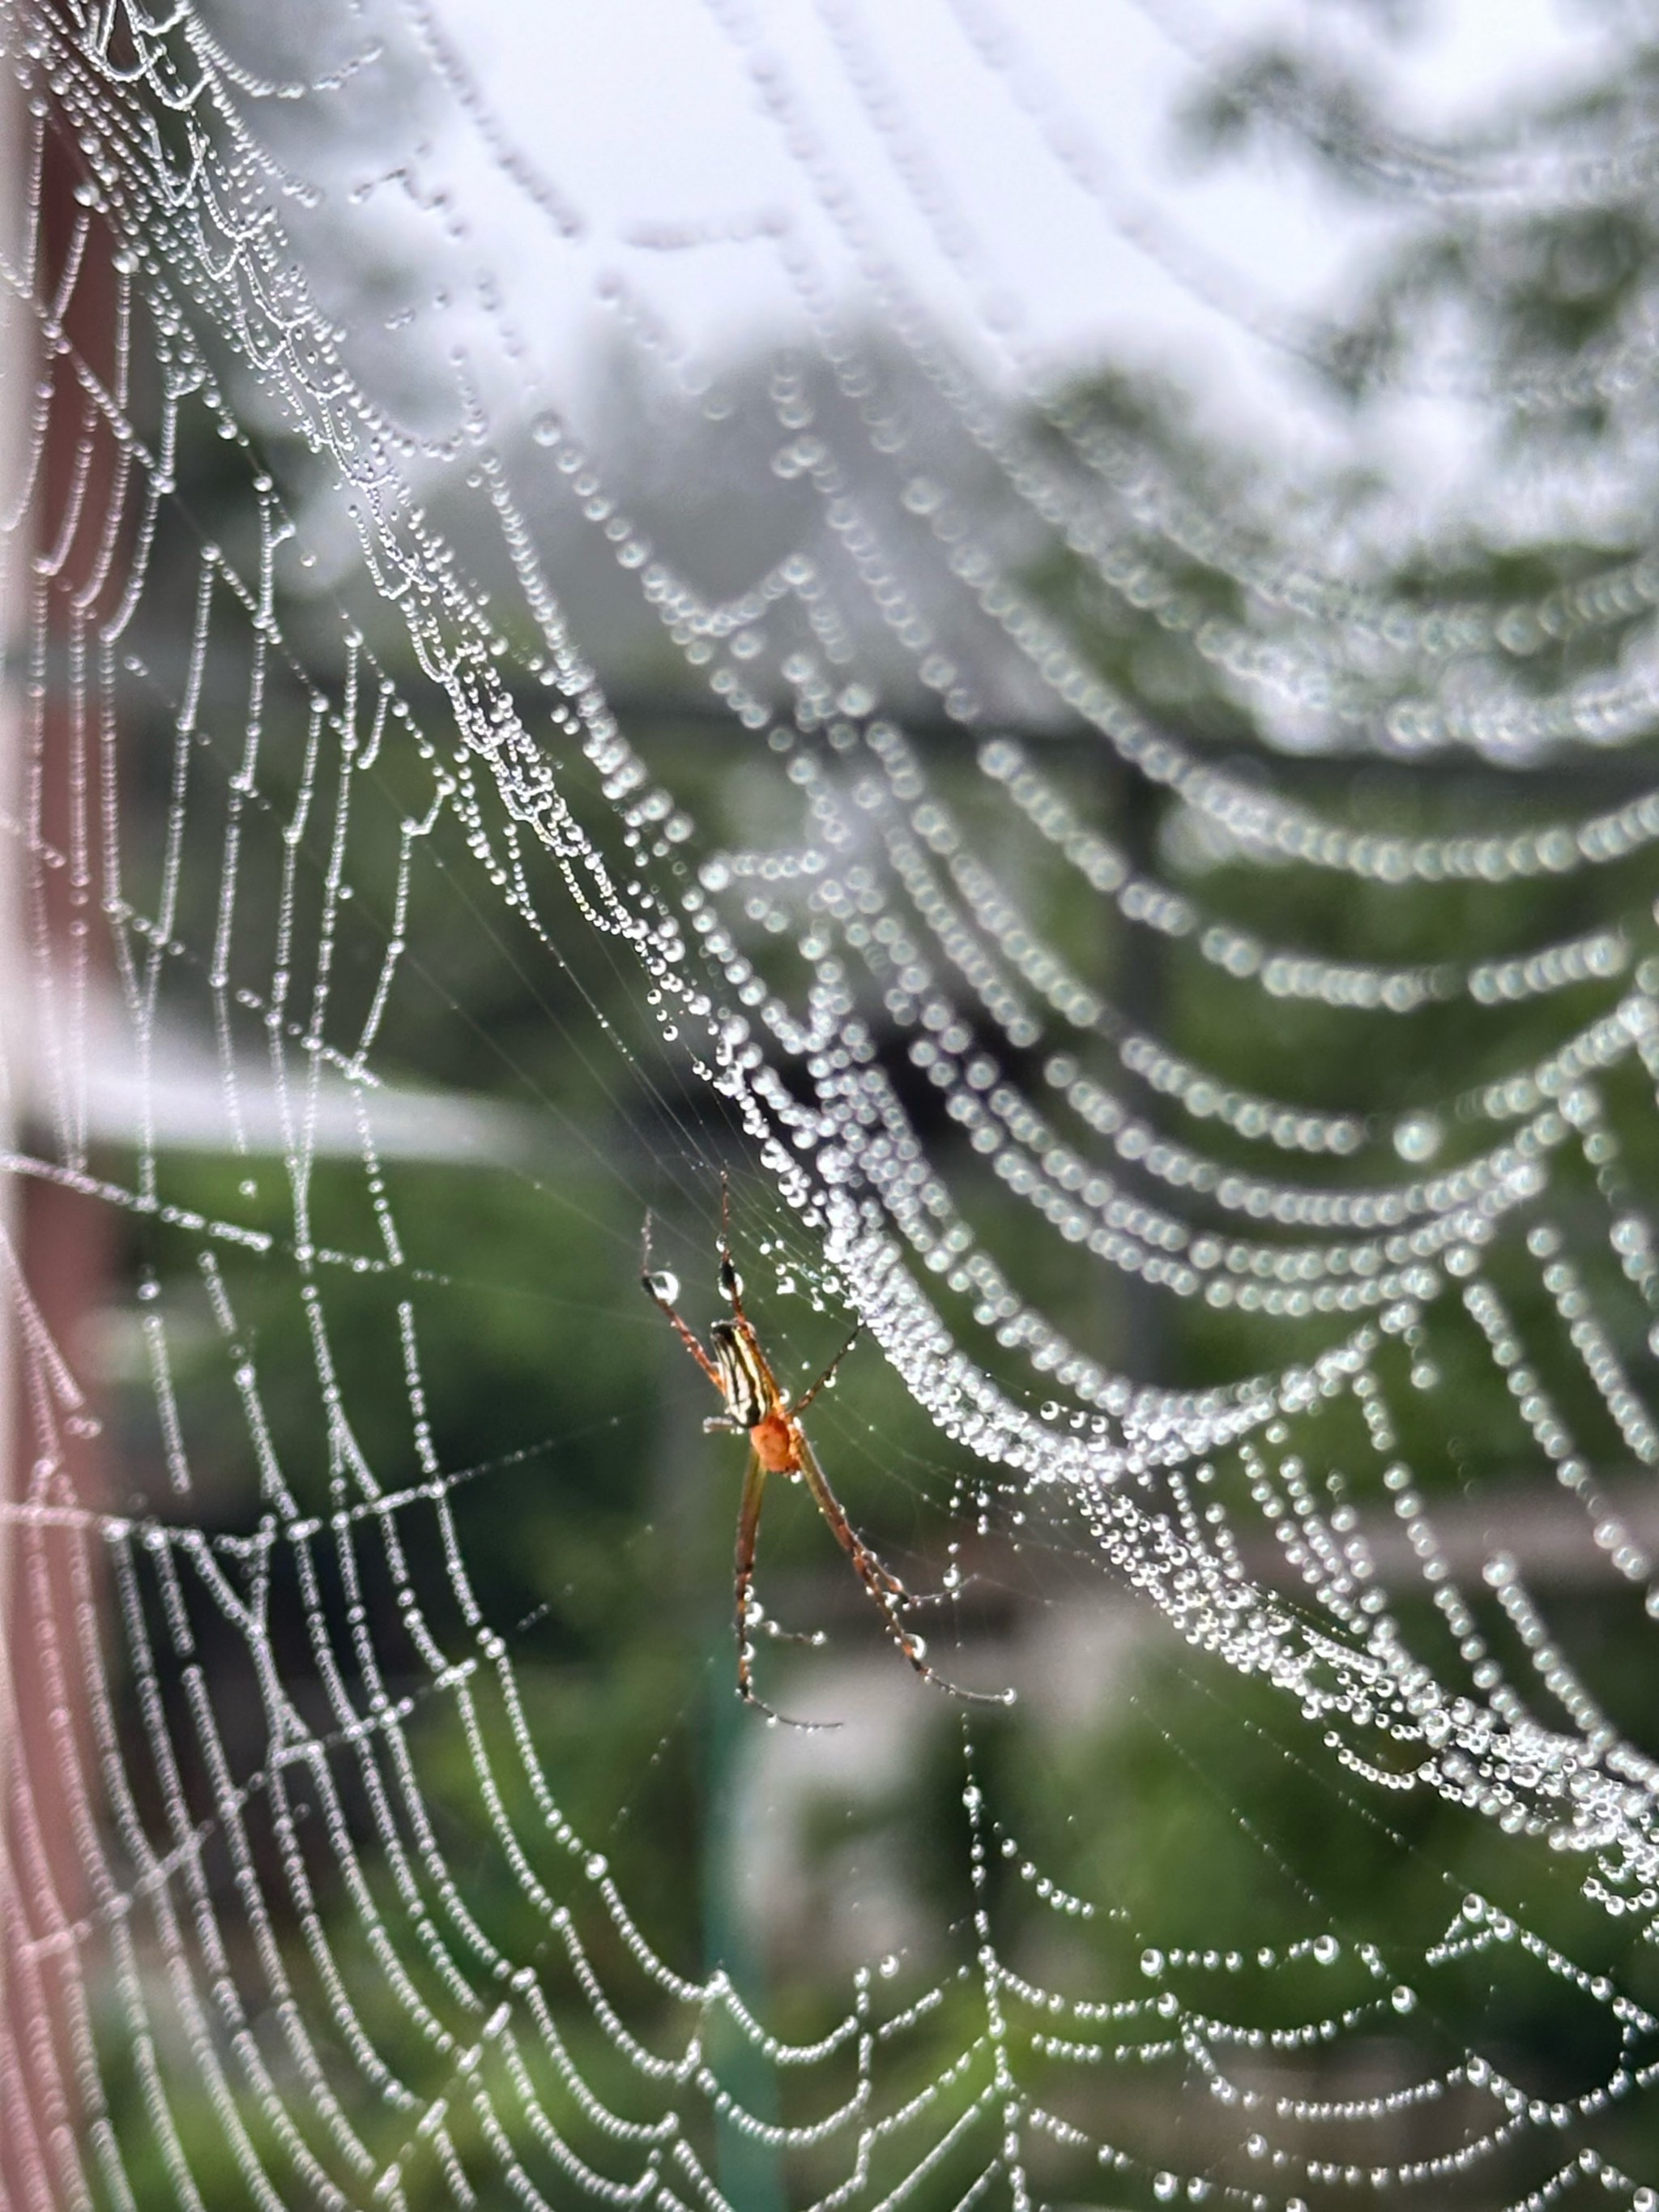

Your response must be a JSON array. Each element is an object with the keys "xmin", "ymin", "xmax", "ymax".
[{"xmin": 0, "ymin": 47, "xmax": 126, "ymax": 2212}]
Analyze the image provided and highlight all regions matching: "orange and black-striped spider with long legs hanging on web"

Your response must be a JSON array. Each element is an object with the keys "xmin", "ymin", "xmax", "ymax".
[{"xmin": 639, "ymin": 1176, "xmax": 1000, "ymax": 1727}]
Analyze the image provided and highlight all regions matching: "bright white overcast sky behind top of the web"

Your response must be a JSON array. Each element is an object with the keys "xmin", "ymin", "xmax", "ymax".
[{"xmin": 413, "ymin": 0, "xmax": 1597, "ymax": 480}]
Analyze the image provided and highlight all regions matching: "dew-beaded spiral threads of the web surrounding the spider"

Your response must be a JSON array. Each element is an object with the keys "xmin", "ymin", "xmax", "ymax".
[{"xmin": 0, "ymin": 0, "xmax": 1659, "ymax": 2208}]
